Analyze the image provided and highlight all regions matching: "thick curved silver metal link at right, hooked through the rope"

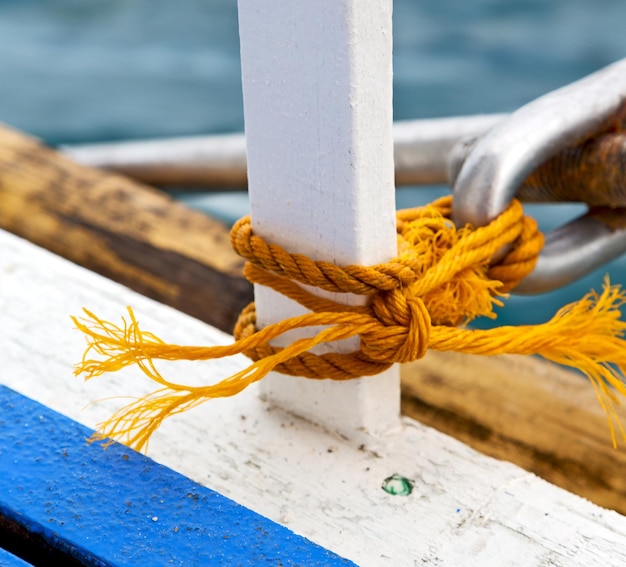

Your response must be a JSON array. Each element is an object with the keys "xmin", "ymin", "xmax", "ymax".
[{"xmin": 452, "ymin": 59, "xmax": 626, "ymax": 293}]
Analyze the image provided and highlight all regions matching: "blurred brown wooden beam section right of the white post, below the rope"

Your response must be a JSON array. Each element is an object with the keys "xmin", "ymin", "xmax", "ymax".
[{"xmin": 402, "ymin": 352, "xmax": 626, "ymax": 514}]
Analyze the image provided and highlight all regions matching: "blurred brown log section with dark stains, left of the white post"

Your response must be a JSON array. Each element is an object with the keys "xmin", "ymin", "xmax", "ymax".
[{"xmin": 0, "ymin": 121, "xmax": 252, "ymax": 331}]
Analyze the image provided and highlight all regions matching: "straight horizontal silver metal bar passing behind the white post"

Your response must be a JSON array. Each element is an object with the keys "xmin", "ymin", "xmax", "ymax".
[{"xmin": 59, "ymin": 114, "xmax": 506, "ymax": 189}]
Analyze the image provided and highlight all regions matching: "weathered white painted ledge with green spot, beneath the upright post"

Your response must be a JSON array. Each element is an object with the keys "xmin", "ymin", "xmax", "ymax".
[{"xmin": 0, "ymin": 232, "xmax": 626, "ymax": 567}]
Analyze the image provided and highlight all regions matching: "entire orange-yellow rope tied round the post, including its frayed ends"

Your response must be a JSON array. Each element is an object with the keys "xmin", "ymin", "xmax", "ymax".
[{"xmin": 72, "ymin": 198, "xmax": 626, "ymax": 450}]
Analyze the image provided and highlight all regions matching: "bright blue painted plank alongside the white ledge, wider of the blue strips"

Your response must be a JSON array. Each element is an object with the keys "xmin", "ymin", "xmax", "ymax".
[{"xmin": 0, "ymin": 386, "xmax": 354, "ymax": 567}]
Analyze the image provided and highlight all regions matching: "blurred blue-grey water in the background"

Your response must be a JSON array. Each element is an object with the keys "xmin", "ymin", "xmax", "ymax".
[{"xmin": 0, "ymin": 0, "xmax": 626, "ymax": 324}]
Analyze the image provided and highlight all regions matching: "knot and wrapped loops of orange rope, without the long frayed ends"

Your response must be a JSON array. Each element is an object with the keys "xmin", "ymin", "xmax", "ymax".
[{"xmin": 231, "ymin": 197, "xmax": 543, "ymax": 374}]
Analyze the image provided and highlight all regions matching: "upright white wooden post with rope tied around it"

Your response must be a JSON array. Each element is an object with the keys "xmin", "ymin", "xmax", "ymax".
[{"xmin": 239, "ymin": 0, "xmax": 400, "ymax": 439}]
